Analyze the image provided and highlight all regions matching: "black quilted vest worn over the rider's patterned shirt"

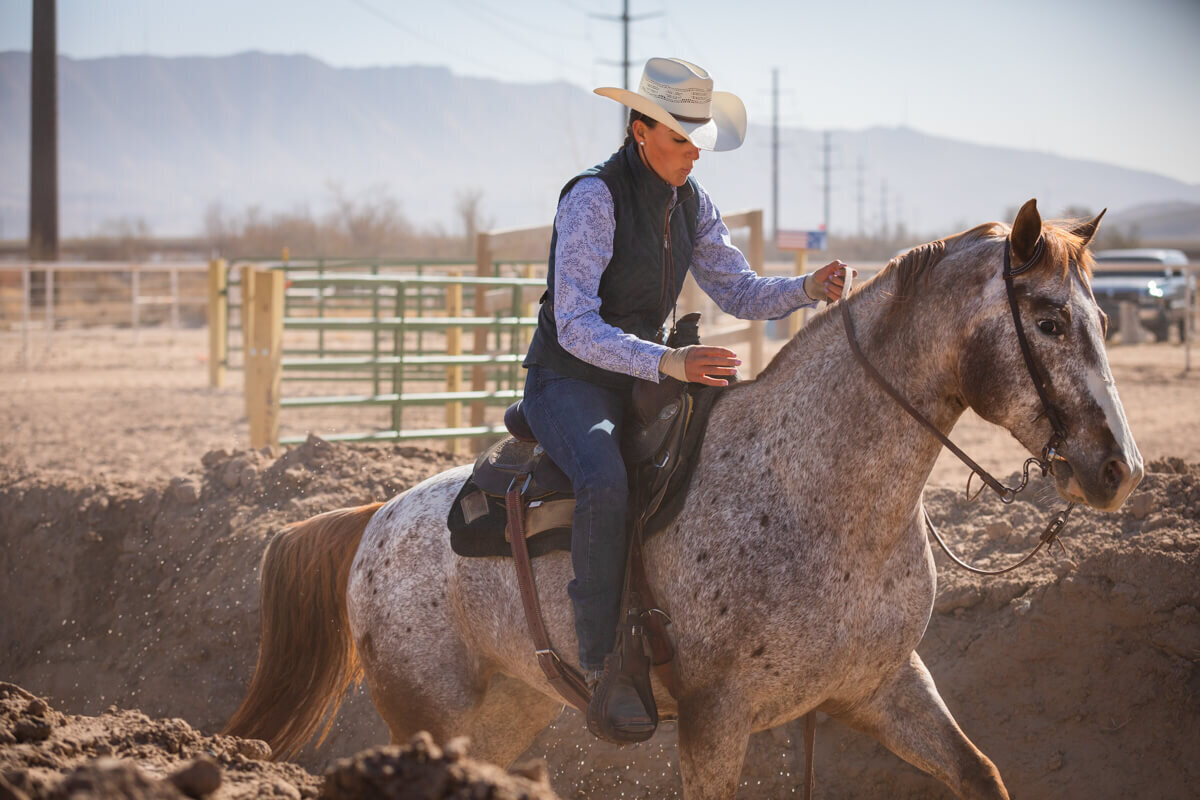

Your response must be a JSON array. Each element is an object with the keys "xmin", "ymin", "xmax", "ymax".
[{"xmin": 524, "ymin": 144, "xmax": 698, "ymax": 389}]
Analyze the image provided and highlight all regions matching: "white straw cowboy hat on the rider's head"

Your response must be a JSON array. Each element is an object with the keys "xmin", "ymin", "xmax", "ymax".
[{"xmin": 595, "ymin": 59, "xmax": 746, "ymax": 151}]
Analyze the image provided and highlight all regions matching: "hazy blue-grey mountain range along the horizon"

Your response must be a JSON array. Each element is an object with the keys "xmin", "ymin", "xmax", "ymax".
[{"xmin": 0, "ymin": 52, "xmax": 1200, "ymax": 244}]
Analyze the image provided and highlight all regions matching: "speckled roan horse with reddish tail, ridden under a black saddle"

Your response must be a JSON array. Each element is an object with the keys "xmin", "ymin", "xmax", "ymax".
[{"xmin": 229, "ymin": 201, "xmax": 1142, "ymax": 800}]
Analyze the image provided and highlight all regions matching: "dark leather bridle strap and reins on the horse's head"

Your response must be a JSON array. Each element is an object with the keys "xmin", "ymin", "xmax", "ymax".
[{"xmin": 841, "ymin": 237, "xmax": 1075, "ymax": 575}]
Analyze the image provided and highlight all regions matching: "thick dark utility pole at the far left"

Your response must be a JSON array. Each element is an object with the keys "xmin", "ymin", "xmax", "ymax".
[{"xmin": 29, "ymin": 0, "xmax": 59, "ymax": 261}]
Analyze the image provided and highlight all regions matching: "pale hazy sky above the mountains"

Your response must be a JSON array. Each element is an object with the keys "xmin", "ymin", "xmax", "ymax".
[{"xmin": 0, "ymin": 0, "xmax": 1200, "ymax": 184}]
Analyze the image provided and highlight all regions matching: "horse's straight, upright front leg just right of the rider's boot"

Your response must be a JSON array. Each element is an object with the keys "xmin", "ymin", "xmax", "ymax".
[{"xmin": 679, "ymin": 688, "xmax": 750, "ymax": 800}]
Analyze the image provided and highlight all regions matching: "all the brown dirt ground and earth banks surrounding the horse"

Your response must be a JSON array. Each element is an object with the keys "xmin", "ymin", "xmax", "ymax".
[{"xmin": 0, "ymin": 330, "xmax": 1200, "ymax": 799}]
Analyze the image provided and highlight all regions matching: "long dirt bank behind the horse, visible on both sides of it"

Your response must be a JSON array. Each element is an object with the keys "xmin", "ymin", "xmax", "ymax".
[{"xmin": 0, "ymin": 439, "xmax": 1200, "ymax": 798}]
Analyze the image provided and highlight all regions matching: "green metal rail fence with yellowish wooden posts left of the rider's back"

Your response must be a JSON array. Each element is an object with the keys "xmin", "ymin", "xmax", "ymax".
[{"xmin": 224, "ymin": 270, "xmax": 544, "ymax": 447}]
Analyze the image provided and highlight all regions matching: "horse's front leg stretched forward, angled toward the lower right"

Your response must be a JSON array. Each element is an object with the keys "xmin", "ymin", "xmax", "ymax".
[{"xmin": 832, "ymin": 651, "xmax": 1008, "ymax": 800}]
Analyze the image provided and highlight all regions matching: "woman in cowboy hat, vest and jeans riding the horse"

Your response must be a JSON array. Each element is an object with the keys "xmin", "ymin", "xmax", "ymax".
[{"xmin": 522, "ymin": 59, "xmax": 845, "ymax": 740}]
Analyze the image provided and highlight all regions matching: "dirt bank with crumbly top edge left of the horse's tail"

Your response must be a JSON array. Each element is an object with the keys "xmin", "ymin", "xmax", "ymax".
[{"xmin": 0, "ymin": 438, "xmax": 452, "ymax": 766}]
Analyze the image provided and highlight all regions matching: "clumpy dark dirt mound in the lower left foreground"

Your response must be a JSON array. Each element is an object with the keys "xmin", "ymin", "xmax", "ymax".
[{"xmin": 0, "ymin": 682, "xmax": 557, "ymax": 800}]
